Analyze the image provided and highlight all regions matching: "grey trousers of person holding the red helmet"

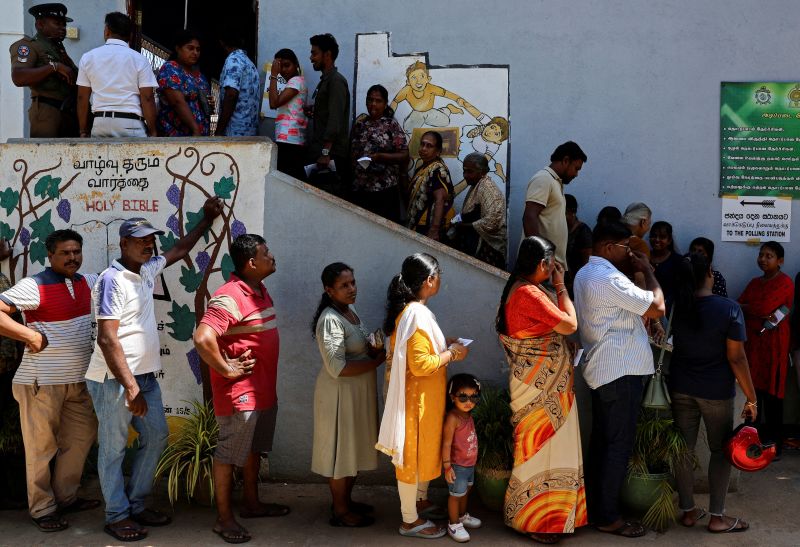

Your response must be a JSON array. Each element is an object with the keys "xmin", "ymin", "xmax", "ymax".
[{"xmin": 670, "ymin": 392, "xmax": 733, "ymax": 515}]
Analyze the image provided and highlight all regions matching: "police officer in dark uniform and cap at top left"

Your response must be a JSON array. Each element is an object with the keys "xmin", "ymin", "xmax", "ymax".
[{"xmin": 9, "ymin": 4, "xmax": 78, "ymax": 138}]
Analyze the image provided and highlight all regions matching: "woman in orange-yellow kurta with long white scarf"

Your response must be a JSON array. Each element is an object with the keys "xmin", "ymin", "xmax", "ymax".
[{"xmin": 376, "ymin": 253, "xmax": 467, "ymax": 538}]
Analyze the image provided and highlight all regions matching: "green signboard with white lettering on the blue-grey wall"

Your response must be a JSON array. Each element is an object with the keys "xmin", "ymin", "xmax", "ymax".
[{"xmin": 719, "ymin": 82, "xmax": 800, "ymax": 198}]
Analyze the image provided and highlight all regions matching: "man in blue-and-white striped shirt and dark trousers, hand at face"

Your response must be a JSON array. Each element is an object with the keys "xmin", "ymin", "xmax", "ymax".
[{"xmin": 574, "ymin": 222, "xmax": 665, "ymax": 537}]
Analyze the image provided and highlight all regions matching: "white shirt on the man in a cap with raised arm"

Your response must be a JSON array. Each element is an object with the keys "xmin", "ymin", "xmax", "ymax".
[{"xmin": 86, "ymin": 256, "xmax": 167, "ymax": 382}]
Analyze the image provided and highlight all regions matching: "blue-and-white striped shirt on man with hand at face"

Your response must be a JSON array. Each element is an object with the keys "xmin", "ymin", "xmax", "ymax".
[{"xmin": 574, "ymin": 256, "xmax": 655, "ymax": 389}]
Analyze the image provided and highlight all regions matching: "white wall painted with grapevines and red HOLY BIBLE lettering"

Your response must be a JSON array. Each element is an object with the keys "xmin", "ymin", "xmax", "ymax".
[{"xmin": 0, "ymin": 139, "xmax": 269, "ymax": 416}]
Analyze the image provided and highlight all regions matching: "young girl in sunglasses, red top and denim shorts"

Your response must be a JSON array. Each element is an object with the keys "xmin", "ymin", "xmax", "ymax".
[{"xmin": 442, "ymin": 374, "xmax": 481, "ymax": 543}]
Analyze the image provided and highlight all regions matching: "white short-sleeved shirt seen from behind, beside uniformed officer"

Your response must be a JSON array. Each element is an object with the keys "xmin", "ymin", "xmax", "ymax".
[{"xmin": 75, "ymin": 38, "xmax": 158, "ymax": 116}]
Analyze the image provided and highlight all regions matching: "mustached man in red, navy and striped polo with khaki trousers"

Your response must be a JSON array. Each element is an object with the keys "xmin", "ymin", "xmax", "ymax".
[{"xmin": 0, "ymin": 230, "xmax": 100, "ymax": 532}]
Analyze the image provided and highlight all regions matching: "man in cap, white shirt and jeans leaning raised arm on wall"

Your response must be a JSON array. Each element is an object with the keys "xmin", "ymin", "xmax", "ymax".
[{"xmin": 86, "ymin": 198, "xmax": 222, "ymax": 541}]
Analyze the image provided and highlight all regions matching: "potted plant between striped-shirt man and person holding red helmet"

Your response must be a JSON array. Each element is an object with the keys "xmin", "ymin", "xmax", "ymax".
[{"xmin": 620, "ymin": 408, "xmax": 693, "ymax": 532}]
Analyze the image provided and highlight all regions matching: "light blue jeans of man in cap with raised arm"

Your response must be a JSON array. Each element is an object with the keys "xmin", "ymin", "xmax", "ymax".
[{"xmin": 86, "ymin": 373, "xmax": 169, "ymax": 524}]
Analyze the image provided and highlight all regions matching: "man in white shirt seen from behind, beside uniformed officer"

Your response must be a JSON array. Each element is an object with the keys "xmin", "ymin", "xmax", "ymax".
[{"xmin": 75, "ymin": 12, "xmax": 158, "ymax": 137}]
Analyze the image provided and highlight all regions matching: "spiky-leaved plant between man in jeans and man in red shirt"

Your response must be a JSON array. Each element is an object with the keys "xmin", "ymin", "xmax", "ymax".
[{"xmin": 156, "ymin": 401, "xmax": 219, "ymax": 506}]
